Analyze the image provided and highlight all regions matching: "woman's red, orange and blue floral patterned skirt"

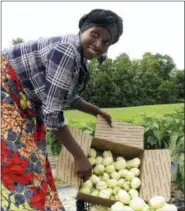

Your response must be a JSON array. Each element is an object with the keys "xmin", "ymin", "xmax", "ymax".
[{"xmin": 1, "ymin": 58, "xmax": 65, "ymax": 211}]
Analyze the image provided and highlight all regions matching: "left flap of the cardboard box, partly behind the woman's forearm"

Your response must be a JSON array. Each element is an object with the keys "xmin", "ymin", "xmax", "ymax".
[{"xmin": 56, "ymin": 127, "xmax": 92, "ymax": 188}]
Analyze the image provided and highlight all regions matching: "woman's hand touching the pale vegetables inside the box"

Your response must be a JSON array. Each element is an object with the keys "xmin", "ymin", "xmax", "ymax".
[{"xmin": 75, "ymin": 156, "xmax": 92, "ymax": 182}]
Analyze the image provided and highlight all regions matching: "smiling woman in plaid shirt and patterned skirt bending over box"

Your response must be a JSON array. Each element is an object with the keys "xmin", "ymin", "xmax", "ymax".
[{"xmin": 1, "ymin": 9, "xmax": 123, "ymax": 211}]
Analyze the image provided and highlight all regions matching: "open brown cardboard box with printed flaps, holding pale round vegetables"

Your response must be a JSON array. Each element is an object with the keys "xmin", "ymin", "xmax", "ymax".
[{"xmin": 56, "ymin": 114, "xmax": 171, "ymax": 207}]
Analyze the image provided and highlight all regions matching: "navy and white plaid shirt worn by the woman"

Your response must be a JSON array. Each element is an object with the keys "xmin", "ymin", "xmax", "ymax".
[{"xmin": 3, "ymin": 35, "xmax": 86, "ymax": 130}]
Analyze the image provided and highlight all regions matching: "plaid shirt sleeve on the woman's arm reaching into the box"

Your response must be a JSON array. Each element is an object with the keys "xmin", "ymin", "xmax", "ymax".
[{"xmin": 42, "ymin": 43, "xmax": 75, "ymax": 130}]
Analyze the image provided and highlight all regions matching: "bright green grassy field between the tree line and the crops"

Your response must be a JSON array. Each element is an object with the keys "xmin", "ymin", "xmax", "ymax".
[{"xmin": 65, "ymin": 103, "xmax": 184, "ymax": 124}]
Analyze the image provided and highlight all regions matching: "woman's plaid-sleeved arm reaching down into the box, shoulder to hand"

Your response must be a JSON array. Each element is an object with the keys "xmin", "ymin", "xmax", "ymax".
[{"xmin": 42, "ymin": 43, "xmax": 92, "ymax": 180}]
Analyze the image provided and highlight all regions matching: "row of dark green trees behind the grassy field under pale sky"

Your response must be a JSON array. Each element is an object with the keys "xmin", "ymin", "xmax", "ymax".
[{"xmin": 82, "ymin": 52, "xmax": 184, "ymax": 107}]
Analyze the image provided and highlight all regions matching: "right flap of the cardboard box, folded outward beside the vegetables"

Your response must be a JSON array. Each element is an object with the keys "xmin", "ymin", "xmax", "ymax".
[{"xmin": 140, "ymin": 149, "xmax": 171, "ymax": 201}]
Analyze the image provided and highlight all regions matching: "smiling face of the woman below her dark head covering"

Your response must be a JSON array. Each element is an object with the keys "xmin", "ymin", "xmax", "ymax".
[{"xmin": 80, "ymin": 27, "xmax": 111, "ymax": 60}]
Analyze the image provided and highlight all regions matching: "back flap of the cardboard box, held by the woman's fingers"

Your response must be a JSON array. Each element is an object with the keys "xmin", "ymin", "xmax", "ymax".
[{"xmin": 95, "ymin": 116, "xmax": 144, "ymax": 149}]
